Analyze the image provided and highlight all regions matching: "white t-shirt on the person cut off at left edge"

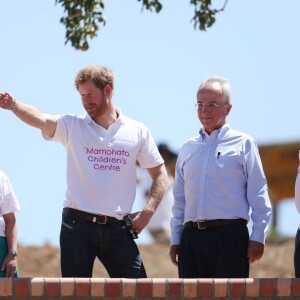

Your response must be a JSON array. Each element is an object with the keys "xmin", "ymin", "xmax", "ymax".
[{"xmin": 0, "ymin": 170, "xmax": 20, "ymax": 236}]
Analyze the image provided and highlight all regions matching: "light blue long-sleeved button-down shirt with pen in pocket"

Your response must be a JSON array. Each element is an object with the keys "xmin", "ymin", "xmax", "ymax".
[{"xmin": 171, "ymin": 123, "xmax": 271, "ymax": 245}]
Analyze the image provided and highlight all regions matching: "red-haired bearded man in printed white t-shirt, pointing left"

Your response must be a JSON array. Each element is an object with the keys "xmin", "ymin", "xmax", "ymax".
[{"xmin": 0, "ymin": 65, "xmax": 167, "ymax": 278}]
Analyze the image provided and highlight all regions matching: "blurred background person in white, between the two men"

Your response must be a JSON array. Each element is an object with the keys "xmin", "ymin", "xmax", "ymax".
[{"xmin": 138, "ymin": 143, "xmax": 177, "ymax": 244}]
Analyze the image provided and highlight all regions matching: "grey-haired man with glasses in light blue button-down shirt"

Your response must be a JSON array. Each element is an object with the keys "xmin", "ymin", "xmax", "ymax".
[{"xmin": 170, "ymin": 77, "xmax": 271, "ymax": 278}]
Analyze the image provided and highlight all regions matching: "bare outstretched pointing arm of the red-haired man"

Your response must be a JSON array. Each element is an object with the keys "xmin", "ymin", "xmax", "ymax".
[{"xmin": 0, "ymin": 92, "xmax": 57, "ymax": 137}]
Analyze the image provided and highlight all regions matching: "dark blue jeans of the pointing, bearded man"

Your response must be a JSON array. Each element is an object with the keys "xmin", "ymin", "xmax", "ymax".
[{"xmin": 60, "ymin": 210, "xmax": 147, "ymax": 278}]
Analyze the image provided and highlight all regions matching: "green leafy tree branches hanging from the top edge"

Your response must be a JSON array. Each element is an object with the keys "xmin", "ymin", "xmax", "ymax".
[{"xmin": 55, "ymin": 0, "xmax": 228, "ymax": 51}]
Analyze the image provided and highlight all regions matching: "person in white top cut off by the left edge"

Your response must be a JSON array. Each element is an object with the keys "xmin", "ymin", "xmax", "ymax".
[{"xmin": 0, "ymin": 170, "xmax": 20, "ymax": 277}]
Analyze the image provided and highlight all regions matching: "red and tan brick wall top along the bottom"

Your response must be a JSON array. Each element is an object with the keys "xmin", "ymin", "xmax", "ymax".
[{"xmin": 0, "ymin": 278, "xmax": 300, "ymax": 300}]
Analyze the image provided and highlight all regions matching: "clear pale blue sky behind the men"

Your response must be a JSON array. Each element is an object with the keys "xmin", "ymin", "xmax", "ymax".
[{"xmin": 0, "ymin": 0, "xmax": 300, "ymax": 245}]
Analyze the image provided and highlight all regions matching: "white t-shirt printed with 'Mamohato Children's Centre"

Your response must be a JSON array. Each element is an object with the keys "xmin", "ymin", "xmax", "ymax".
[{"xmin": 44, "ymin": 111, "xmax": 164, "ymax": 219}]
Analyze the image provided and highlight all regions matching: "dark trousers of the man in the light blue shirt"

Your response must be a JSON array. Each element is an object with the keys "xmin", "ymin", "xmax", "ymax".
[{"xmin": 178, "ymin": 223, "xmax": 249, "ymax": 278}]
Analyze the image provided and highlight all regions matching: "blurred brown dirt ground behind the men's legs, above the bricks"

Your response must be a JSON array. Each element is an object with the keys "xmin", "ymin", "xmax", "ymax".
[{"xmin": 18, "ymin": 239, "xmax": 294, "ymax": 278}]
